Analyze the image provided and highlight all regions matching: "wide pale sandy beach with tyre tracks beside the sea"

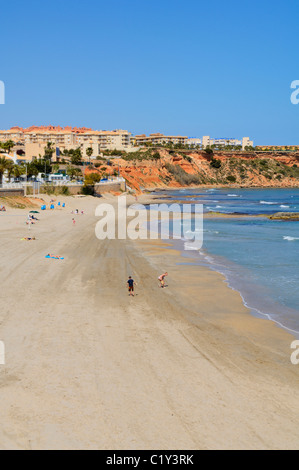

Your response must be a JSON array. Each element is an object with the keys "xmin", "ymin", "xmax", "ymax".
[{"xmin": 0, "ymin": 196, "xmax": 299, "ymax": 450}]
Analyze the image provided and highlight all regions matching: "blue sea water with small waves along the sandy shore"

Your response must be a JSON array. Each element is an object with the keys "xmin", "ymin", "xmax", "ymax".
[{"xmin": 156, "ymin": 189, "xmax": 299, "ymax": 337}]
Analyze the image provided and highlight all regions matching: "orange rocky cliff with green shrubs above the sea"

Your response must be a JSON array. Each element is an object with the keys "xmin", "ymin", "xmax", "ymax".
[{"xmin": 94, "ymin": 149, "xmax": 299, "ymax": 192}]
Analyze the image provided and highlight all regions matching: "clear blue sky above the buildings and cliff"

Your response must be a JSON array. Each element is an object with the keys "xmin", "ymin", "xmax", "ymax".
[{"xmin": 0, "ymin": 0, "xmax": 299, "ymax": 144}]
